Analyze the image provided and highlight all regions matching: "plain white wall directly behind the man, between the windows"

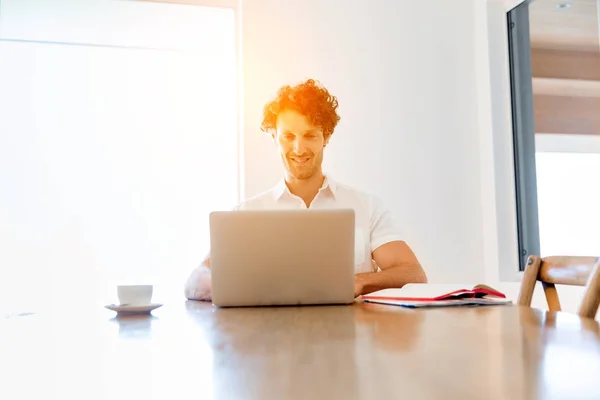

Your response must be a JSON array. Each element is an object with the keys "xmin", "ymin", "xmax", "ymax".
[{"xmin": 242, "ymin": 0, "xmax": 484, "ymax": 282}]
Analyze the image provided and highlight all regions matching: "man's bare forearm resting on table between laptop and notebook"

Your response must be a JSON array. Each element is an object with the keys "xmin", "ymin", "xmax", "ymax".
[{"xmin": 356, "ymin": 264, "xmax": 427, "ymax": 295}]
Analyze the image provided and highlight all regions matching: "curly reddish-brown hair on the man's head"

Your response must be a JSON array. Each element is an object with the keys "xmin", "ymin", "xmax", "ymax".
[{"xmin": 261, "ymin": 79, "xmax": 340, "ymax": 138}]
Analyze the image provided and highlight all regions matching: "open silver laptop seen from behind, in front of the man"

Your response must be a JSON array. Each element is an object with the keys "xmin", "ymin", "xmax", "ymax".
[{"xmin": 210, "ymin": 209, "xmax": 355, "ymax": 307}]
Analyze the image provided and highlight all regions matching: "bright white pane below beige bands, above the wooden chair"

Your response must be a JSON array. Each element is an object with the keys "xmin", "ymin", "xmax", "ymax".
[{"xmin": 536, "ymin": 135, "xmax": 600, "ymax": 256}]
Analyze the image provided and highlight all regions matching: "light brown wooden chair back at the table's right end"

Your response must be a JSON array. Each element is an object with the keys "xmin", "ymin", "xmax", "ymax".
[{"xmin": 517, "ymin": 256, "xmax": 600, "ymax": 318}]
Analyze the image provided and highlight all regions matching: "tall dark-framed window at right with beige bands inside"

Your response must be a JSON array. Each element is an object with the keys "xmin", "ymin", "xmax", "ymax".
[{"xmin": 508, "ymin": 0, "xmax": 600, "ymax": 270}]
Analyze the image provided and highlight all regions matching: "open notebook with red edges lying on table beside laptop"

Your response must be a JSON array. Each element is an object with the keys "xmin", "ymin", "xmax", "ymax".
[{"xmin": 361, "ymin": 284, "xmax": 511, "ymax": 307}]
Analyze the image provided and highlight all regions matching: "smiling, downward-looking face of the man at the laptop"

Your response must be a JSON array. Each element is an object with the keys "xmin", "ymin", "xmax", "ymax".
[{"xmin": 274, "ymin": 110, "xmax": 327, "ymax": 179}]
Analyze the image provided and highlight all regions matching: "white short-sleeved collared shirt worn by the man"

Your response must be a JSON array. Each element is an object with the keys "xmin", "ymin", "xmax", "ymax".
[{"xmin": 236, "ymin": 177, "xmax": 403, "ymax": 274}]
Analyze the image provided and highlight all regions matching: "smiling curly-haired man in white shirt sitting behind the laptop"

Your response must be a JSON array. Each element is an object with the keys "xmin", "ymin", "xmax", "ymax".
[{"xmin": 185, "ymin": 79, "xmax": 427, "ymax": 301}]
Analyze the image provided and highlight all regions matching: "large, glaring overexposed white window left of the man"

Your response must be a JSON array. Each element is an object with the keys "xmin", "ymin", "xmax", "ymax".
[{"xmin": 0, "ymin": 6, "xmax": 238, "ymax": 311}]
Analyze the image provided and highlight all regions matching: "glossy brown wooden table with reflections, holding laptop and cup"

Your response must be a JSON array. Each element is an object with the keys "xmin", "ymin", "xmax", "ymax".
[{"xmin": 0, "ymin": 302, "xmax": 600, "ymax": 400}]
